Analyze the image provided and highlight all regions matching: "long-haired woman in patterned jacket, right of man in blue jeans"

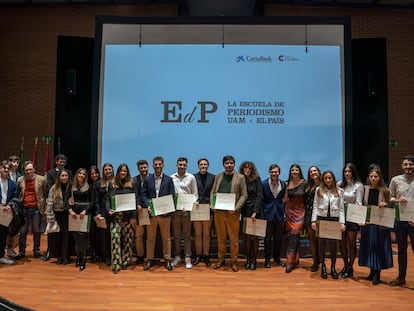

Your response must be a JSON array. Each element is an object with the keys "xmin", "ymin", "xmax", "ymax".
[{"xmin": 46, "ymin": 169, "xmax": 72, "ymax": 265}]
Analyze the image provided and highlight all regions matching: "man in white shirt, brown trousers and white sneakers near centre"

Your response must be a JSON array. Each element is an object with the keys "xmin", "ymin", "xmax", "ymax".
[{"xmin": 171, "ymin": 157, "xmax": 198, "ymax": 269}]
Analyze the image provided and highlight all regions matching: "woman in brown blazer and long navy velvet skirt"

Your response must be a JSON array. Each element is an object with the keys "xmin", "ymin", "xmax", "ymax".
[{"xmin": 358, "ymin": 167, "xmax": 393, "ymax": 285}]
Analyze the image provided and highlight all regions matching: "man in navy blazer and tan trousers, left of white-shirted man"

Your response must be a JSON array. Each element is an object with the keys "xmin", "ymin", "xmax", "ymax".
[{"xmin": 141, "ymin": 156, "xmax": 174, "ymax": 270}]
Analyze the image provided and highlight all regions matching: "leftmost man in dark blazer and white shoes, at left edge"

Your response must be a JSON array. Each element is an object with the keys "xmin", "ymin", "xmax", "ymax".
[{"xmin": 0, "ymin": 161, "xmax": 17, "ymax": 265}]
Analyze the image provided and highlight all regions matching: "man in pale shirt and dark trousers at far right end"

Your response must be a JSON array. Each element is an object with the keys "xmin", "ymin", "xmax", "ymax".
[{"xmin": 390, "ymin": 155, "xmax": 414, "ymax": 286}]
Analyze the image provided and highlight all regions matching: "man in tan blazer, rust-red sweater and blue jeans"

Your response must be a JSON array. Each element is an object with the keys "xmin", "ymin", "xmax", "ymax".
[{"xmin": 17, "ymin": 161, "xmax": 47, "ymax": 258}]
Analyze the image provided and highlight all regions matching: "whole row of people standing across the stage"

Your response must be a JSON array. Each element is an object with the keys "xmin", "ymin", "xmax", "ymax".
[{"xmin": 0, "ymin": 154, "xmax": 414, "ymax": 286}]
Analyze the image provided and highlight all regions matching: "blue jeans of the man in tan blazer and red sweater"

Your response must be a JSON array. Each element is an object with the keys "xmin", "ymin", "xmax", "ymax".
[{"xmin": 19, "ymin": 207, "xmax": 42, "ymax": 254}]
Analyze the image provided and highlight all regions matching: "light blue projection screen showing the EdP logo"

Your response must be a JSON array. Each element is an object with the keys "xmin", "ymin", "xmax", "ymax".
[{"xmin": 98, "ymin": 22, "xmax": 344, "ymax": 179}]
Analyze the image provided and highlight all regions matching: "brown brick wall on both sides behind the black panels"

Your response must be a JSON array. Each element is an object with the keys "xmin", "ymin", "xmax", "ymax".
[{"xmin": 0, "ymin": 5, "xmax": 414, "ymax": 180}]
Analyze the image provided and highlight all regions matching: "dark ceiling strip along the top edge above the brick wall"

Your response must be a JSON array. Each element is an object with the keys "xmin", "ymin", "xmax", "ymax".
[{"xmin": 0, "ymin": 0, "xmax": 414, "ymax": 16}]
